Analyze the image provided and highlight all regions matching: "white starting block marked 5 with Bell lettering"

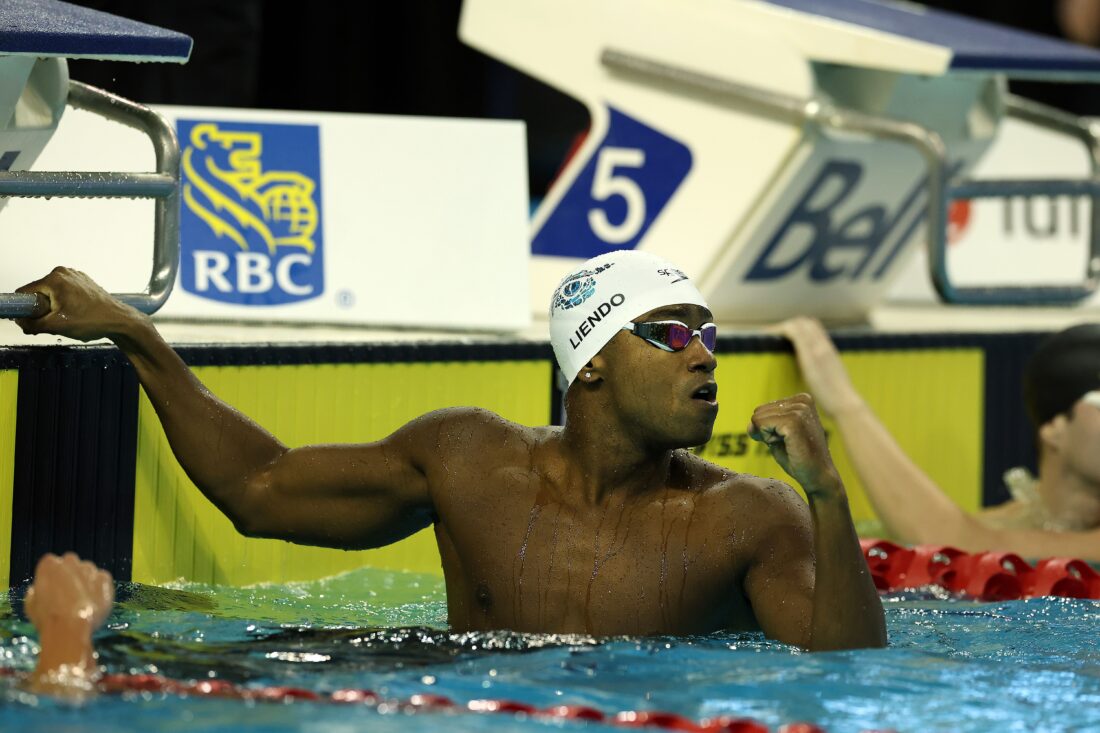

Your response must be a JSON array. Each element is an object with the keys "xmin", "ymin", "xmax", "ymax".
[{"xmin": 460, "ymin": 0, "xmax": 1100, "ymax": 320}]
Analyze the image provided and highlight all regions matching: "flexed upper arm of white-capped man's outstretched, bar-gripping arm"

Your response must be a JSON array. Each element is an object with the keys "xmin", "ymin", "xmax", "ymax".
[{"xmin": 238, "ymin": 413, "xmax": 432, "ymax": 549}]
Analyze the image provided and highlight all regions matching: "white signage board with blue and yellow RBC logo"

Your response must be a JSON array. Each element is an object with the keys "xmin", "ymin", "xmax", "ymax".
[{"xmin": 0, "ymin": 101, "xmax": 530, "ymax": 330}]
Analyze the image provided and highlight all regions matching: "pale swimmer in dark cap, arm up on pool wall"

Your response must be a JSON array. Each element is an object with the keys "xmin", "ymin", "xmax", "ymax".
[{"xmin": 778, "ymin": 318, "xmax": 1100, "ymax": 562}]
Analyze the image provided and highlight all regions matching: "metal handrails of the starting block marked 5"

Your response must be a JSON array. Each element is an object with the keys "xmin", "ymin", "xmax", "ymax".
[{"xmin": 601, "ymin": 48, "xmax": 1100, "ymax": 305}]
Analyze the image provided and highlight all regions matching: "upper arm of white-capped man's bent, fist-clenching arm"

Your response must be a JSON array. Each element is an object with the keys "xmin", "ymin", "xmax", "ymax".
[{"xmin": 744, "ymin": 491, "xmax": 814, "ymax": 647}]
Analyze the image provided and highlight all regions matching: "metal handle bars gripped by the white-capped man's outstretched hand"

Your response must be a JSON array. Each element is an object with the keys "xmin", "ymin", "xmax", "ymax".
[{"xmin": 0, "ymin": 80, "xmax": 179, "ymax": 318}]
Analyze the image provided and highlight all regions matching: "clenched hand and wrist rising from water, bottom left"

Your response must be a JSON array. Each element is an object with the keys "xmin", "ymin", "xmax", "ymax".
[{"xmin": 22, "ymin": 553, "xmax": 114, "ymax": 700}]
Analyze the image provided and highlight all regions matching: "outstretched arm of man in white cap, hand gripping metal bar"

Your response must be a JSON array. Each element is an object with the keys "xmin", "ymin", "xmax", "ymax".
[{"xmin": 18, "ymin": 267, "xmax": 433, "ymax": 548}]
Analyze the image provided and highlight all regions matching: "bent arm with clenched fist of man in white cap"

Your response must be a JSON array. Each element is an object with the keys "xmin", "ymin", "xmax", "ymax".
[{"xmin": 747, "ymin": 394, "xmax": 887, "ymax": 652}]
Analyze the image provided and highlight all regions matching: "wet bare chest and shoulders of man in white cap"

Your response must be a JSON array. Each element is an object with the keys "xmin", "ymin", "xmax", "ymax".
[{"xmin": 429, "ymin": 412, "xmax": 813, "ymax": 634}]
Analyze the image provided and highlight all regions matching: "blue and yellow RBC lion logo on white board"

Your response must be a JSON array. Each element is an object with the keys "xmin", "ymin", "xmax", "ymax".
[{"xmin": 179, "ymin": 120, "xmax": 325, "ymax": 305}]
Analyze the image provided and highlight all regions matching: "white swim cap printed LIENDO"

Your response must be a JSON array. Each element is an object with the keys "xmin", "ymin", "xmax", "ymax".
[{"xmin": 550, "ymin": 250, "xmax": 706, "ymax": 384}]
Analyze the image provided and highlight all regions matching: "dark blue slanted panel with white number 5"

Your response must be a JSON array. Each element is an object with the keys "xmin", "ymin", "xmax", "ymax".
[{"xmin": 531, "ymin": 108, "xmax": 692, "ymax": 260}]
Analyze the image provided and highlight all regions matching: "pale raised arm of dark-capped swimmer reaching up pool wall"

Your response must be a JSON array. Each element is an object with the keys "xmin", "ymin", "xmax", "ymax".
[{"xmin": 779, "ymin": 318, "xmax": 988, "ymax": 549}]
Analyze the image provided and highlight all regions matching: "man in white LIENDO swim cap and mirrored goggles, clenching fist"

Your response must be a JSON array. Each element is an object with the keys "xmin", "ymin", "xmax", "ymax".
[{"xmin": 18, "ymin": 252, "xmax": 886, "ymax": 650}]
